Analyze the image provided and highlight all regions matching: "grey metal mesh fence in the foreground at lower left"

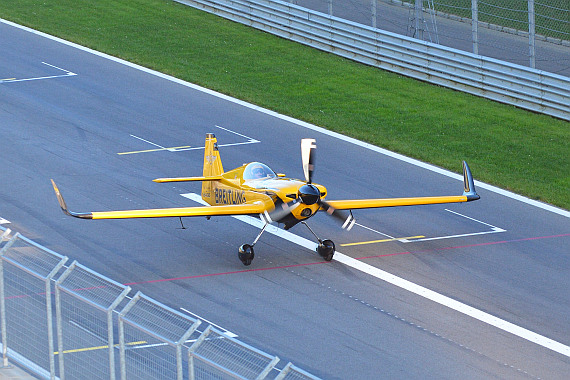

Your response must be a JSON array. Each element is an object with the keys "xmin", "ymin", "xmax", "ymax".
[{"xmin": 0, "ymin": 226, "xmax": 317, "ymax": 380}]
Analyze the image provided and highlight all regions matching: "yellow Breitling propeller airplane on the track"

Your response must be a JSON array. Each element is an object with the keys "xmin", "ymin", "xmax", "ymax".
[{"xmin": 51, "ymin": 133, "xmax": 479, "ymax": 265}]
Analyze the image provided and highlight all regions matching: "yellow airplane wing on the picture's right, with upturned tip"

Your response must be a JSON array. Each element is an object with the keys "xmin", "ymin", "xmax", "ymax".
[{"xmin": 326, "ymin": 161, "xmax": 480, "ymax": 212}]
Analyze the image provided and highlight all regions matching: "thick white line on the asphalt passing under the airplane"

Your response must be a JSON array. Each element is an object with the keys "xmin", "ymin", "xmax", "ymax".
[{"xmin": 180, "ymin": 193, "xmax": 570, "ymax": 357}]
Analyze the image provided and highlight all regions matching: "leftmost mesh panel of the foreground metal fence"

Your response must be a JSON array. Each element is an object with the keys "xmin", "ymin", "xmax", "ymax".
[{"xmin": 0, "ymin": 234, "xmax": 67, "ymax": 376}]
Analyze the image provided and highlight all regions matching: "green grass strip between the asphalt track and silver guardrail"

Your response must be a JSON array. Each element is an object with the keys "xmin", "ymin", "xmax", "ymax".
[{"xmin": 0, "ymin": 0, "xmax": 570, "ymax": 209}]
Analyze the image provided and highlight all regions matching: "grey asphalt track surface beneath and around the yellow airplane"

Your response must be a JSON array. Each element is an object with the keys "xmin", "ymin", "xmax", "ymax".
[{"xmin": 0, "ymin": 23, "xmax": 570, "ymax": 379}]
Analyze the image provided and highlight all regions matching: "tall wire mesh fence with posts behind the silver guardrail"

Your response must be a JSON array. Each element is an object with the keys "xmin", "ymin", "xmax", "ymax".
[{"xmin": 283, "ymin": 0, "xmax": 570, "ymax": 77}]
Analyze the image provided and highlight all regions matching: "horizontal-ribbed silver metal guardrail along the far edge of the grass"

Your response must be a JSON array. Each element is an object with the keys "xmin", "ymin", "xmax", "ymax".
[{"xmin": 174, "ymin": 0, "xmax": 570, "ymax": 120}]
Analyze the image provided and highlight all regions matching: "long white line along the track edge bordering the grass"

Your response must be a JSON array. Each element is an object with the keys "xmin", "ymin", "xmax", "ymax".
[{"xmin": 0, "ymin": 18, "xmax": 560, "ymax": 218}]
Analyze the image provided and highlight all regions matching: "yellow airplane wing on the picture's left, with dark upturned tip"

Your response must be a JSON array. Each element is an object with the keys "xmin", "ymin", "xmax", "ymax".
[{"xmin": 51, "ymin": 179, "xmax": 273, "ymax": 219}]
